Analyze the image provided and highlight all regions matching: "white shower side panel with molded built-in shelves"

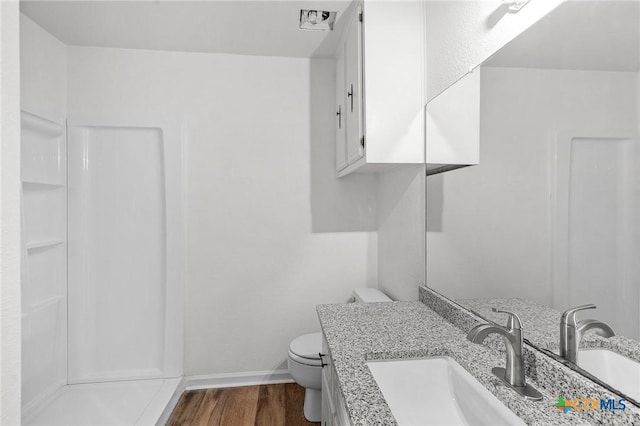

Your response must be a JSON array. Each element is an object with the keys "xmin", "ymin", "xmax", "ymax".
[{"xmin": 21, "ymin": 111, "xmax": 67, "ymax": 412}]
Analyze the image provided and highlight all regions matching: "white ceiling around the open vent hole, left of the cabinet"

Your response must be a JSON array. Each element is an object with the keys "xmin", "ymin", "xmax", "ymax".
[{"xmin": 20, "ymin": 0, "xmax": 351, "ymax": 58}]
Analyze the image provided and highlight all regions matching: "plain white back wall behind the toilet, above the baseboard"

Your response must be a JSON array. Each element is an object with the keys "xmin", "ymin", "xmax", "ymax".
[{"xmin": 68, "ymin": 47, "xmax": 377, "ymax": 375}]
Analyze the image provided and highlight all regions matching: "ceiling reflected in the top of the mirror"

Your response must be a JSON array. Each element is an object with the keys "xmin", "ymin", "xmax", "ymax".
[{"xmin": 485, "ymin": 0, "xmax": 640, "ymax": 71}]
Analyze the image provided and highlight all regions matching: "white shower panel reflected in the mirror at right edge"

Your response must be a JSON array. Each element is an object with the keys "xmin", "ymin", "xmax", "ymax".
[{"xmin": 568, "ymin": 138, "xmax": 640, "ymax": 338}]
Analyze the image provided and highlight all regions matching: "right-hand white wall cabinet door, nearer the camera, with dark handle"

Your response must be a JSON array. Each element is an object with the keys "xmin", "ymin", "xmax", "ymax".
[{"xmin": 344, "ymin": 6, "xmax": 364, "ymax": 164}]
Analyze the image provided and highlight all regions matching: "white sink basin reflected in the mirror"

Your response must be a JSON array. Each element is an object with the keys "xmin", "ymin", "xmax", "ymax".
[{"xmin": 578, "ymin": 349, "xmax": 640, "ymax": 400}]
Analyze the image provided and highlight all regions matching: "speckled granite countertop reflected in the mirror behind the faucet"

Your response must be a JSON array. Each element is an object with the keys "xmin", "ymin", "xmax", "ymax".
[{"xmin": 456, "ymin": 298, "xmax": 640, "ymax": 362}]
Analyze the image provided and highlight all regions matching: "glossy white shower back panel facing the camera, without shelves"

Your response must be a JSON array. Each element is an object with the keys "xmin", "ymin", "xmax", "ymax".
[{"xmin": 68, "ymin": 124, "xmax": 182, "ymax": 383}]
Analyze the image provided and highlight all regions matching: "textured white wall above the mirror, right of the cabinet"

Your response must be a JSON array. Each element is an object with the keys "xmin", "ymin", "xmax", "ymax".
[{"xmin": 425, "ymin": 0, "xmax": 565, "ymax": 100}]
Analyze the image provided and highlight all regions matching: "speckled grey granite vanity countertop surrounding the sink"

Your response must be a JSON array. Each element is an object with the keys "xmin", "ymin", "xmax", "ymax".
[{"xmin": 317, "ymin": 302, "xmax": 640, "ymax": 426}]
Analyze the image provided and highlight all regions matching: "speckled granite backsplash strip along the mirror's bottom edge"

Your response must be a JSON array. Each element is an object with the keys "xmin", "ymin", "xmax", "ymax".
[{"xmin": 419, "ymin": 287, "xmax": 640, "ymax": 425}]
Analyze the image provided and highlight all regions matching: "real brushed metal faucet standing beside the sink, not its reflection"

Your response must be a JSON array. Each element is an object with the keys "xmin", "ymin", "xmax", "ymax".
[{"xmin": 467, "ymin": 308, "xmax": 542, "ymax": 401}]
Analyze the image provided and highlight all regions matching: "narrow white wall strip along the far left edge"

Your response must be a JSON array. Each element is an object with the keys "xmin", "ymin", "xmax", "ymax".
[{"xmin": 0, "ymin": 1, "xmax": 21, "ymax": 425}]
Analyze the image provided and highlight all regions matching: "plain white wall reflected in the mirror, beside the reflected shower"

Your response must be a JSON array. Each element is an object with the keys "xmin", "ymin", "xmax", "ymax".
[{"xmin": 427, "ymin": 68, "xmax": 638, "ymax": 305}]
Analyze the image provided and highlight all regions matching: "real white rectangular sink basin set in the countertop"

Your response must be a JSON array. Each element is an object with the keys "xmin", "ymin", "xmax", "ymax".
[{"xmin": 367, "ymin": 357, "xmax": 525, "ymax": 426}]
